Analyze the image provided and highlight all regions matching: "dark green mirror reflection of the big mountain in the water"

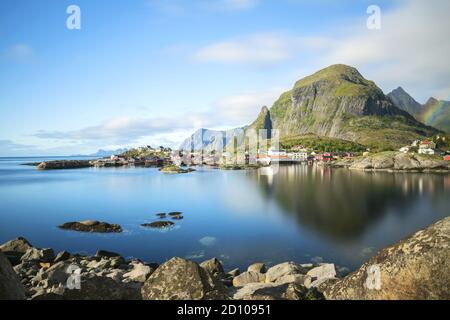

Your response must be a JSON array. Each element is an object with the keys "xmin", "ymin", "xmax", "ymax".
[{"xmin": 249, "ymin": 165, "xmax": 449, "ymax": 242}]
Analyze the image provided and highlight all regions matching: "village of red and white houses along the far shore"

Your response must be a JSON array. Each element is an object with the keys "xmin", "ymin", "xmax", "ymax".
[{"xmin": 92, "ymin": 136, "xmax": 450, "ymax": 167}]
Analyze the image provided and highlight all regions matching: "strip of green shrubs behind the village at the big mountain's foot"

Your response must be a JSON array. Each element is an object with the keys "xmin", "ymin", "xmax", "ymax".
[{"xmin": 280, "ymin": 134, "xmax": 366, "ymax": 152}]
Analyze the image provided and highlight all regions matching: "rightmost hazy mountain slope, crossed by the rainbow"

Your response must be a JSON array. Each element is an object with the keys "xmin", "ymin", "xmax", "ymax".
[{"xmin": 420, "ymin": 98, "xmax": 450, "ymax": 133}]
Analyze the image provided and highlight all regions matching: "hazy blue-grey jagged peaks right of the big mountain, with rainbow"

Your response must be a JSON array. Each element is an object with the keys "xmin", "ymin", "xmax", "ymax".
[{"xmin": 388, "ymin": 87, "xmax": 450, "ymax": 133}]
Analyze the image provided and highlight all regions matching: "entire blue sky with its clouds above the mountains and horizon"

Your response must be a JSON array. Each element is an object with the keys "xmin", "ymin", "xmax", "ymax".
[{"xmin": 0, "ymin": 0, "xmax": 450, "ymax": 156}]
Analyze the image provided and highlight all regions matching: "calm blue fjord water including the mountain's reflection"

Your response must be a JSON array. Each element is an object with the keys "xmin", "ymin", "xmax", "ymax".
[{"xmin": 0, "ymin": 158, "xmax": 450, "ymax": 270}]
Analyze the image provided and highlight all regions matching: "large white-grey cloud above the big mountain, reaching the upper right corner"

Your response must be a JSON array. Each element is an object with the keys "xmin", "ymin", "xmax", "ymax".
[{"xmin": 194, "ymin": 0, "xmax": 450, "ymax": 100}]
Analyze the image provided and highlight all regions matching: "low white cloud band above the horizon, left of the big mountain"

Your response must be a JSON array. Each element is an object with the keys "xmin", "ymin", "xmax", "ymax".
[{"xmin": 33, "ymin": 89, "xmax": 279, "ymax": 145}]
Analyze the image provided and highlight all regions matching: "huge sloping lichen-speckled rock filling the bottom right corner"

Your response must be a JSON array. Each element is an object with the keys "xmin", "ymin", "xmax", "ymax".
[{"xmin": 324, "ymin": 217, "xmax": 450, "ymax": 300}]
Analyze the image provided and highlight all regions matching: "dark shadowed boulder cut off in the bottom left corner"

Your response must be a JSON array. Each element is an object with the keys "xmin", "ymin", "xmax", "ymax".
[{"xmin": 0, "ymin": 252, "xmax": 26, "ymax": 300}]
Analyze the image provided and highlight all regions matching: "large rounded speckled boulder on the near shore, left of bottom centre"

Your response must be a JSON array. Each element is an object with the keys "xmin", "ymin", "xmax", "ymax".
[{"xmin": 141, "ymin": 258, "xmax": 226, "ymax": 300}]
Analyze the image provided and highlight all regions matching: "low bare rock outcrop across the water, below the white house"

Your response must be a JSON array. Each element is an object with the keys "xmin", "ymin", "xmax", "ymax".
[{"xmin": 328, "ymin": 151, "xmax": 450, "ymax": 172}]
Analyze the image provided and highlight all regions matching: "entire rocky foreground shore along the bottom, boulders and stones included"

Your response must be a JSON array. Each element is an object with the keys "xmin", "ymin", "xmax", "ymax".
[{"xmin": 0, "ymin": 217, "xmax": 450, "ymax": 300}]
